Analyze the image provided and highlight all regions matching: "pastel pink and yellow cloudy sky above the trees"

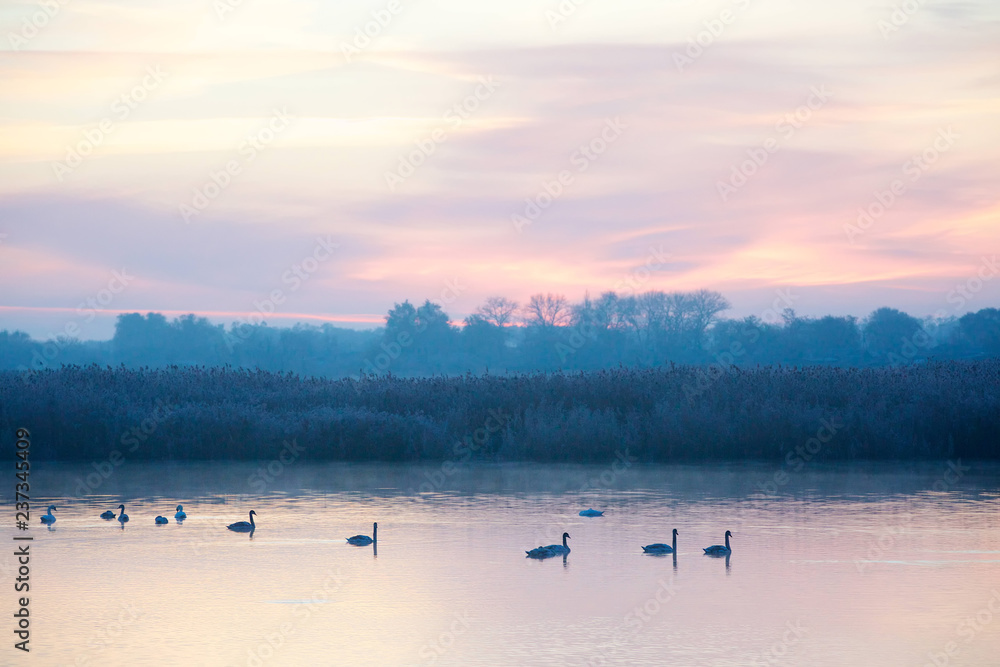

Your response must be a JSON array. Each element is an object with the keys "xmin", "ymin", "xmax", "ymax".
[{"xmin": 0, "ymin": 0, "xmax": 1000, "ymax": 339}]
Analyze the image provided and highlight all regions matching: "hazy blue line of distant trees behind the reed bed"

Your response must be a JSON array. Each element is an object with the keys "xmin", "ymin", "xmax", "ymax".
[{"xmin": 0, "ymin": 290, "xmax": 1000, "ymax": 377}]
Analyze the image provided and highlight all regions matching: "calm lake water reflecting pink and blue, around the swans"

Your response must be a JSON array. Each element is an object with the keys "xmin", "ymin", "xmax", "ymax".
[{"xmin": 11, "ymin": 463, "xmax": 1000, "ymax": 667}]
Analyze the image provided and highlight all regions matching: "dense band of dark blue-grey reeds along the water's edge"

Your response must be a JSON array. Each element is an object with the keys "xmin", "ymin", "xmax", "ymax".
[{"xmin": 0, "ymin": 359, "xmax": 1000, "ymax": 469}]
